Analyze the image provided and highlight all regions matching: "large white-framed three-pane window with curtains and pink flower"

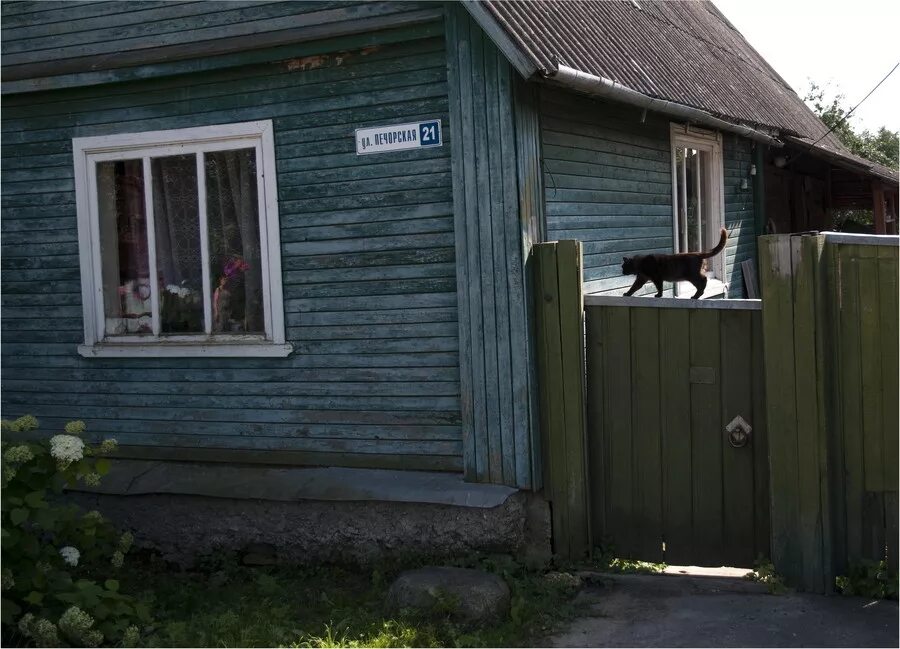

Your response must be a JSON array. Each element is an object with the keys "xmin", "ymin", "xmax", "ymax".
[{"xmin": 72, "ymin": 121, "xmax": 291, "ymax": 356}]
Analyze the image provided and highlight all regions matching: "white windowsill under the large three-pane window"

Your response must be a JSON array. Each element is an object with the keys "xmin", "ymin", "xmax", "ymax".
[{"xmin": 78, "ymin": 341, "xmax": 294, "ymax": 358}]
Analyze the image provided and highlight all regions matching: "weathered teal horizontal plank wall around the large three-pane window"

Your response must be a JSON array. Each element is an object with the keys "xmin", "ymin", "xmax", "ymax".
[{"xmin": 2, "ymin": 21, "xmax": 462, "ymax": 471}]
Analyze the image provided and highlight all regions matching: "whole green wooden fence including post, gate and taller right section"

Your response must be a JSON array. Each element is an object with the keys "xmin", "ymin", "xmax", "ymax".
[{"xmin": 535, "ymin": 234, "xmax": 900, "ymax": 592}]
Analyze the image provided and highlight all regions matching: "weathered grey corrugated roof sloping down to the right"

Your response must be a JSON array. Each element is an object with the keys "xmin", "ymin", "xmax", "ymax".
[{"xmin": 480, "ymin": 0, "xmax": 897, "ymax": 180}]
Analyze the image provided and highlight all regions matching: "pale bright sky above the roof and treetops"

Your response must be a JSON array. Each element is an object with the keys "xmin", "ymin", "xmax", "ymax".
[{"xmin": 713, "ymin": 0, "xmax": 900, "ymax": 131}]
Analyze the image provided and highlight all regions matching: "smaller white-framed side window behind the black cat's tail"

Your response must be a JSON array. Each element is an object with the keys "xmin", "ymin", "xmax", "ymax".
[{"xmin": 671, "ymin": 124, "xmax": 725, "ymax": 295}]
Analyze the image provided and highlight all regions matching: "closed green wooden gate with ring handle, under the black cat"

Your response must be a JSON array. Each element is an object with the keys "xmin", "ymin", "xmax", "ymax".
[{"xmin": 585, "ymin": 296, "xmax": 769, "ymax": 566}]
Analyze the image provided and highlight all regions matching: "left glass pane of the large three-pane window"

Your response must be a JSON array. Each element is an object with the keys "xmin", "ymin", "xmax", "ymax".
[{"xmin": 96, "ymin": 160, "xmax": 153, "ymax": 336}]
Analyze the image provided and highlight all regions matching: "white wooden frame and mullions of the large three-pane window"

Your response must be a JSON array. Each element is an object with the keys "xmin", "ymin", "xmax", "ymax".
[{"xmin": 72, "ymin": 120, "xmax": 293, "ymax": 358}]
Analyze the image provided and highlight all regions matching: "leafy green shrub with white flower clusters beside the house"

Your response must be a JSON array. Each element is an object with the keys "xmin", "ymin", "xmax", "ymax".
[{"xmin": 0, "ymin": 416, "xmax": 148, "ymax": 647}]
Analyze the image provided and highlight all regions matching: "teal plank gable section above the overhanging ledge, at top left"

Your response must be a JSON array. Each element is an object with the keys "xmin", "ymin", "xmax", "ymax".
[{"xmin": 0, "ymin": 1, "xmax": 441, "ymax": 88}]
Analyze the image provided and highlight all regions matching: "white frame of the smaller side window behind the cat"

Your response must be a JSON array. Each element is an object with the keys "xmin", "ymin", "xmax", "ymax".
[{"xmin": 670, "ymin": 124, "xmax": 728, "ymax": 297}]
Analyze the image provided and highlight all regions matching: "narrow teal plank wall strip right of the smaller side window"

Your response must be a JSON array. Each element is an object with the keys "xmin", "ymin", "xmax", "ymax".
[{"xmin": 722, "ymin": 133, "xmax": 762, "ymax": 298}]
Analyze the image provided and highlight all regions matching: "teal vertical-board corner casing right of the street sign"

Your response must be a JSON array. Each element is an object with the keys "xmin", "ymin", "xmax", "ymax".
[{"xmin": 447, "ymin": 6, "xmax": 534, "ymax": 488}]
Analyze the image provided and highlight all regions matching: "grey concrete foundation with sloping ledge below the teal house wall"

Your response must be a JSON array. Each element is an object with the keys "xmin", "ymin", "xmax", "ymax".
[{"xmin": 68, "ymin": 459, "xmax": 550, "ymax": 566}]
